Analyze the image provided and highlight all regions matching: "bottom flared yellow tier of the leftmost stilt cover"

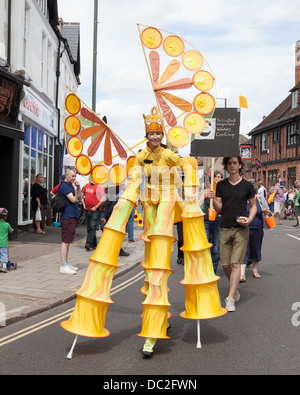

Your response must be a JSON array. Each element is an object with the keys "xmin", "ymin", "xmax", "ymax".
[{"xmin": 60, "ymin": 296, "xmax": 110, "ymax": 338}]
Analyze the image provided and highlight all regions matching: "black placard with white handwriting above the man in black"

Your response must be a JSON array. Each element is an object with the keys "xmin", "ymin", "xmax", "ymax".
[{"xmin": 191, "ymin": 108, "xmax": 240, "ymax": 157}]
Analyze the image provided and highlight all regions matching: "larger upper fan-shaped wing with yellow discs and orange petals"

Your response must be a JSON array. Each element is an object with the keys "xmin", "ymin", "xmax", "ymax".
[{"xmin": 138, "ymin": 25, "xmax": 216, "ymax": 148}]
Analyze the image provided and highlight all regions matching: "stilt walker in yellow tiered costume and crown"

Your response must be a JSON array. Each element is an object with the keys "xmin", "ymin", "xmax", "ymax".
[{"xmin": 61, "ymin": 107, "xmax": 226, "ymax": 358}]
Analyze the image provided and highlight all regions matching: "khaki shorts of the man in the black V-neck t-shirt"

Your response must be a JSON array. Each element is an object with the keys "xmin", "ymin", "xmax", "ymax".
[{"xmin": 220, "ymin": 227, "xmax": 249, "ymax": 266}]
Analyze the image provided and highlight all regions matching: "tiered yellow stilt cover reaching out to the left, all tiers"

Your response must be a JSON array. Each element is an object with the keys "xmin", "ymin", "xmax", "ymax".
[{"xmin": 61, "ymin": 199, "xmax": 134, "ymax": 338}]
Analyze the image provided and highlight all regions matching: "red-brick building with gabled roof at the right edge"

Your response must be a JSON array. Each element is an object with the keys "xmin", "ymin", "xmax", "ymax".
[{"xmin": 247, "ymin": 41, "xmax": 300, "ymax": 189}]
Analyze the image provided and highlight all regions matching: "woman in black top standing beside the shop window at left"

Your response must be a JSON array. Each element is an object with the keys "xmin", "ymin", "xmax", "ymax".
[{"xmin": 31, "ymin": 173, "xmax": 48, "ymax": 235}]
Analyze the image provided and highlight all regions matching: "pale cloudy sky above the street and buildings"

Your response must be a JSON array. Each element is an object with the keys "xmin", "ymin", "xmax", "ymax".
[{"xmin": 58, "ymin": 0, "xmax": 300, "ymax": 158}]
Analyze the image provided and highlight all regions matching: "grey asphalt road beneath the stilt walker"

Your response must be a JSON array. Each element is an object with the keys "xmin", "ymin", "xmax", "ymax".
[{"xmin": 0, "ymin": 221, "xmax": 300, "ymax": 378}]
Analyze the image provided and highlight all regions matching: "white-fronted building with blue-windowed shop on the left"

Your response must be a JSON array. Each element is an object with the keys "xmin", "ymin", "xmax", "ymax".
[{"xmin": 0, "ymin": 0, "xmax": 80, "ymax": 235}]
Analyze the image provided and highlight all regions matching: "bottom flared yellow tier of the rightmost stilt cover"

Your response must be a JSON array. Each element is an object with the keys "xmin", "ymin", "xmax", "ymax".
[{"xmin": 180, "ymin": 282, "xmax": 227, "ymax": 320}]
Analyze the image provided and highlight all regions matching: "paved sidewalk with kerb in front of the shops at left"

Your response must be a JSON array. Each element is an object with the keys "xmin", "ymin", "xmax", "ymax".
[{"xmin": 0, "ymin": 222, "xmax": 144, "ymax": 326}]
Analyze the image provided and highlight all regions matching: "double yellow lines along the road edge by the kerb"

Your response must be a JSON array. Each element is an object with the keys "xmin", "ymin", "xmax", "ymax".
[{"xmin": 0, "ymin": 272, "xmax": 145, "ymax": 347}]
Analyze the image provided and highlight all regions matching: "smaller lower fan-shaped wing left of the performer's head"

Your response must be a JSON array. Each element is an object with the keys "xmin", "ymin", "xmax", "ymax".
[{"xmin": 64, "ymin": 87, "xmax": 139, "ymax": 185}]
